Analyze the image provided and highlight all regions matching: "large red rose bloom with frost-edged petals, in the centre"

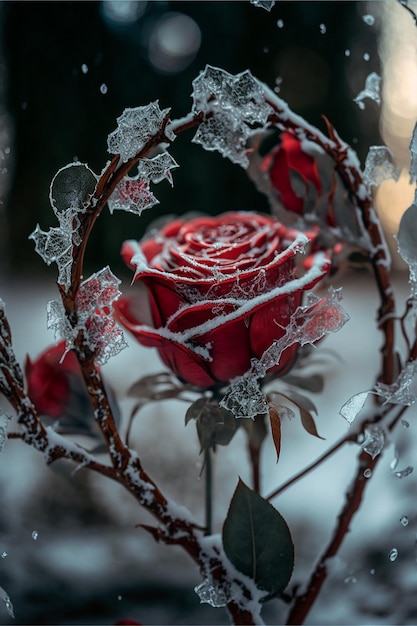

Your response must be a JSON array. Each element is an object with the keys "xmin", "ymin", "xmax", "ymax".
[{"xmin": 114, "ymin": 212, "xmax": 330, "ymax": 388}]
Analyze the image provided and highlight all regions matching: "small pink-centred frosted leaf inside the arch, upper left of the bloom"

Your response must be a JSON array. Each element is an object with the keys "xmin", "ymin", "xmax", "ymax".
[{"xmin": 107, "ymin": 176, "xmax": 159, "ymax": 215}]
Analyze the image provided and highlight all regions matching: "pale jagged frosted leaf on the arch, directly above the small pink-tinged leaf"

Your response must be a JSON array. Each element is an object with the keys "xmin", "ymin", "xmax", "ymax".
[{"xmin": 107, "ymin": 101, "xmax": 175, "ymax": 163}]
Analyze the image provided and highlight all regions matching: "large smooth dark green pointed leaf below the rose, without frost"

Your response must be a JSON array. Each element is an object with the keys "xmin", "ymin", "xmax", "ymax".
[{"xmin": 223, "ymin": 480, "xmax": 294, "ymax": 597}]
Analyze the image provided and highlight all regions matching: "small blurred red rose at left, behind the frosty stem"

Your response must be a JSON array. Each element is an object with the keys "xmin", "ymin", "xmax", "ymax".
[{"xmin": 25, "ymin": 341, "xmax": 81, "ymax": 418}]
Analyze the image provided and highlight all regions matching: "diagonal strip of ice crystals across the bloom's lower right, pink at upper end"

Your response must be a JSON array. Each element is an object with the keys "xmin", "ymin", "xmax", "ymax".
[{"xmin": 220, "ymin": 289, "xmax": 349, "ymax": 418}]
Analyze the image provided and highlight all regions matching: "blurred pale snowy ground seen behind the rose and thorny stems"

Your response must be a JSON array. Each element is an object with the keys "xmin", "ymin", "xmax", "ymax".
[{"xmin": 0, "ymin": 266, "xmax": 417, "ymax": 625}]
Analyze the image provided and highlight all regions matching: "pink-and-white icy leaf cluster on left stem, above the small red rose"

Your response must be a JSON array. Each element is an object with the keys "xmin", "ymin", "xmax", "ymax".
[{"xmin": 47, "ymin": 267, "xmax": 127, "ymax": 365}]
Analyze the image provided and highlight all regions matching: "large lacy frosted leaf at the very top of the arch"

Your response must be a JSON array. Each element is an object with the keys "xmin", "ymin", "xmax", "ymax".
[{"xmin": 192, "ymin": 65, "xmax": 272, "ymax": 168}]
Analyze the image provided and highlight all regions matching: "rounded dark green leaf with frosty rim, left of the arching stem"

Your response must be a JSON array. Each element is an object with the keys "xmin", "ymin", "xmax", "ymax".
[{"xmin": 49, "ymin": 163, "xmax": 97, "ymax": 213}]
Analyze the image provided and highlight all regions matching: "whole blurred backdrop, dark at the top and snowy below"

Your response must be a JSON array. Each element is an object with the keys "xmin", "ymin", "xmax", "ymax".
[{"xmin": 0, "ymin": 0, "xmax": 417, "ymax": 626}]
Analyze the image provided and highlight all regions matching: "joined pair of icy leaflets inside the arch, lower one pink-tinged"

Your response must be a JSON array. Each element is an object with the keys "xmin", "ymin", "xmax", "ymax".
[{"xmin": 108, "ymin": 152, "xmax": 178, "ymax": 215}]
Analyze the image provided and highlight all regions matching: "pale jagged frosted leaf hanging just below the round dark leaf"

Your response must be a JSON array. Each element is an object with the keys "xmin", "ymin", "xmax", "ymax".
[{"xmin": 29, "ymin": 224, "xmax": 72, "ymax": 287}]
